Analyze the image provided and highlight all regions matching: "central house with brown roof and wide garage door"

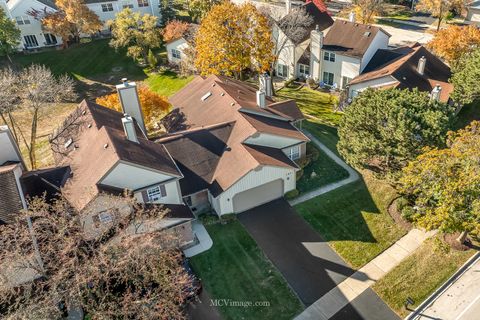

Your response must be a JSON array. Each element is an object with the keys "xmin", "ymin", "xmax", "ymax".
[{"xmin": 163, "ymin": 76, "xmax": 309, "ymax": 215}]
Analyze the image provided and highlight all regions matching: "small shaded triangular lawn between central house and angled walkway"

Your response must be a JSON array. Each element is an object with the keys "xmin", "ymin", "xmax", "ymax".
[{"xmin": 297, "ymin": 143, "xmax": 348, "ymax": 194}]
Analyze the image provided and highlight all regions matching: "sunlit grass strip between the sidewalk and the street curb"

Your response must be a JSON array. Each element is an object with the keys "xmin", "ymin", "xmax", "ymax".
[{"xmin": 373, "ymin": 238, "xmax": 474, "ymax": 318}]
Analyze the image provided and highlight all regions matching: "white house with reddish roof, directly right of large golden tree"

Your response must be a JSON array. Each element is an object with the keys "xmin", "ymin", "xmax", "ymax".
[{"xmin": 272, "ymin": 0, "xmax": 334, "ymax": 78}]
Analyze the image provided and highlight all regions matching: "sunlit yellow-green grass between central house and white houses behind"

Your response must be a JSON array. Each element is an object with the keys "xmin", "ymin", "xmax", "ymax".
[{"xmin": 277, "ymin": 86, "xmax": 342, "ymax": 126}]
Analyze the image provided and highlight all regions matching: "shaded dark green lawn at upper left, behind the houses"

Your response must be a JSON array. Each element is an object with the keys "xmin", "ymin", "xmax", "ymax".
[{"xmin": 13, "ymin": 39, "xmax": 146, "ymax": 79}]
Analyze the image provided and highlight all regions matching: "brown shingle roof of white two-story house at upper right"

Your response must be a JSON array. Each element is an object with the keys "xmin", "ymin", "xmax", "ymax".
[{"xmin": 322, "ymin": 19, "xmax": 390, "ymax": 58}]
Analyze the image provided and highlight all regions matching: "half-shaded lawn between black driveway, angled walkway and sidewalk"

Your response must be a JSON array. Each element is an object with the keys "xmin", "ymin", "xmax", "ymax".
[{"xmin": 295, "ymin": 173, "xmax": 405, "ymax": 268}]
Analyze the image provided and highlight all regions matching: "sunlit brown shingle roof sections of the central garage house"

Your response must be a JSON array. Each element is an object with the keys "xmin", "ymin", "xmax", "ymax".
[{"xmin": 166, "ymin": 76, "xmax": 308, "ymax": 194}]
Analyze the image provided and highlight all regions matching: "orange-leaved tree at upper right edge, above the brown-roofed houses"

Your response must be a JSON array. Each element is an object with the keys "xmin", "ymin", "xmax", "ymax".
[{"xmin": 428, "ymin": 25, "xmax": 480, "ymax": 65}]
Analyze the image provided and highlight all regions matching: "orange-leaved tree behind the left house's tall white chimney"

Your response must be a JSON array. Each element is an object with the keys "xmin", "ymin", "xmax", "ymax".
[{"xmin": 96, "ymin": 85, "xmax": 170, "ymax": 130}]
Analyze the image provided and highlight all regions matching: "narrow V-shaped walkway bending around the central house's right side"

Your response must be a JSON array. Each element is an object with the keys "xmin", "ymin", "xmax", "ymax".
[{"xmin": 289, "ymin": 129, "xmax": 359, "ymax": 206}]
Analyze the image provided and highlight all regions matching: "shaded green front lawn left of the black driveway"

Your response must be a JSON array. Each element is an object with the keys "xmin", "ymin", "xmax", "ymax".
[{"xmin": 191, "ymin": 220, "xmax": 303, "ymax": 320}]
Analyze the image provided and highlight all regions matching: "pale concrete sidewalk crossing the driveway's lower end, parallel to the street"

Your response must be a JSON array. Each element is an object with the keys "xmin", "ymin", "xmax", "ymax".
[{"xmin": 295, "ymin": 229, "xmax": 435, "ymax": 320}]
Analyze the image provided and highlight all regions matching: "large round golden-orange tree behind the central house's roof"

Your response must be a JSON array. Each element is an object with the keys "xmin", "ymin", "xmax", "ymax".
[{"xmin": 195, "ymin": 2, "xmax": 274, "ymax": 79}]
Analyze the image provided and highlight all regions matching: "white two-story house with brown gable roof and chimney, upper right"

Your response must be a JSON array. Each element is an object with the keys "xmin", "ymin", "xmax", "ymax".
[{"xmin": 310, "ymin": 17, "xmax": 390, "ymax": 89}]
